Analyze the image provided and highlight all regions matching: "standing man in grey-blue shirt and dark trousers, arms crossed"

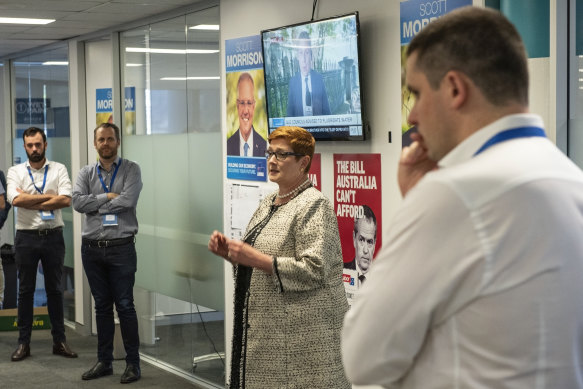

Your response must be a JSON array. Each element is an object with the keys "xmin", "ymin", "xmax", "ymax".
[{"xmin": 73, "ymin": 123, "xmax": 142, "ymax": 383}]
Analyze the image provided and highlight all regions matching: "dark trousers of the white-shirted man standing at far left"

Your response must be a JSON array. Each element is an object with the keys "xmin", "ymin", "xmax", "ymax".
[{"xmin": 14, "ymin": 229, "xmax": 66, "ymax": 344}]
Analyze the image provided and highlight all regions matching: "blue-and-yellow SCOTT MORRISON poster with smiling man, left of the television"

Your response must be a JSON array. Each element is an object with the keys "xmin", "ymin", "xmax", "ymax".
[{"xmin": 225, "ymin": 35, "xmax": 267, "ymax": 181}]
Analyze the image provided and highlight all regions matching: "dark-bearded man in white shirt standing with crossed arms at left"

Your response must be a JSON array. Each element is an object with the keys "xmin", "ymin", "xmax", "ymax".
[{"xmin": 6, "ymin": 127, "xmax": 77, "ymax": 362}]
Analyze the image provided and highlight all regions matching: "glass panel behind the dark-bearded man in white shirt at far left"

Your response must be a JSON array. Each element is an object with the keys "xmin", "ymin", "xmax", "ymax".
[{"xmin": 11, "ymin": 45, "xmax": 75, "ymax": 321}]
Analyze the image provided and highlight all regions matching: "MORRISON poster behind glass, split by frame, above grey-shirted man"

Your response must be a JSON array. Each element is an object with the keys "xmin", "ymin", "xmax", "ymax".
[{"xmin": 95, "ymin": 86, "xmax": 136, "ymax": 135}]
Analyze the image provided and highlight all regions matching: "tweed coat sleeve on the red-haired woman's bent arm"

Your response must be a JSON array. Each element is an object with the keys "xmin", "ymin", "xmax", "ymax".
[{"xmin": 273, "ymin": 198, "xmax": 342, "ymax": 293}]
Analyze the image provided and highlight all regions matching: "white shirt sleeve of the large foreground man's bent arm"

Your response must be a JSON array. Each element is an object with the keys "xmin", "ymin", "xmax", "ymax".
[{"xmin": 342, "ymin": 183, "xmax": 483, "ymax": 388}]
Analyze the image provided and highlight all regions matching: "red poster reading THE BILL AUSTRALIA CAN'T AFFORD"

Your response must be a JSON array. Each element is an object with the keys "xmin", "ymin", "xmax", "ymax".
[{"xmin": 334, "ymin": 154, "xmax": 382, "ymax": 304}]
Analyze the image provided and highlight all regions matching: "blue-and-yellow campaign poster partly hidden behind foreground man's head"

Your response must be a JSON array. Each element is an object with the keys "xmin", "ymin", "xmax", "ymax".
[{"xmin": 400, "ymin": 0, "xmax": 472, "ymax": 147}]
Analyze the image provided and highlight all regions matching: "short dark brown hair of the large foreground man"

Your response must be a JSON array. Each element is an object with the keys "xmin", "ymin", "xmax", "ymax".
[{"xmin": 407, "ymin": 6, "xmax": 528, "ymax": 106}]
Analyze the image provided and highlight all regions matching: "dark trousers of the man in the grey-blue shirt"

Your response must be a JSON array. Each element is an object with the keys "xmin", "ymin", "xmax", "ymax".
[{"xmin": 81, "ymin": 239, "xmax": 140, "ymax": 366}]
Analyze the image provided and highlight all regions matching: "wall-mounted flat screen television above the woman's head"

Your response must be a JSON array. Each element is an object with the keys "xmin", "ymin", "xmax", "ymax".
[{"xmin": 261, "ymin": 12, "xmax": 366, "ymax": 140}]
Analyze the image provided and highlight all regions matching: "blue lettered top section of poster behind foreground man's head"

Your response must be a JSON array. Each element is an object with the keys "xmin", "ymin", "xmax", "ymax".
[{"xmin": 401, "ymin": 0, "xmax": 472, "ymax": 46}]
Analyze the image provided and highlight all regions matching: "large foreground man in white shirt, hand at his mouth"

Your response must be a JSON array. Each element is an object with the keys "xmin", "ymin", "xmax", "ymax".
[{"xmin": 342, "ymin": 7, "xmax": 583, "ymax": 389}]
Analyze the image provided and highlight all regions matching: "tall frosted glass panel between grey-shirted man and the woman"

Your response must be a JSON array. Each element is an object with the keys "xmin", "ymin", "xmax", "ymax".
[{"xmin": 120, "ymin": 7, "xmax": 225, "ymax": 387}]
